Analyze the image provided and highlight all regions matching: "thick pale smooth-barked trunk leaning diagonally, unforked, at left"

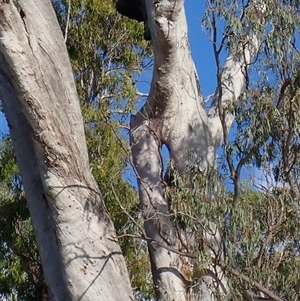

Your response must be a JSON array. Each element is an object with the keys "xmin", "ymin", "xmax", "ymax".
[{"xmin": 0, "ymin": 0, "xmax": 132, "ymax": 301}]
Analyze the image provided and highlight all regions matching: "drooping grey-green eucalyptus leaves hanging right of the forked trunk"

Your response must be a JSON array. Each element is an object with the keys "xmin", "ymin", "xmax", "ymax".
[{"xmin": 167, "ymin": 1, "xmax": 300, "ymax": 300}]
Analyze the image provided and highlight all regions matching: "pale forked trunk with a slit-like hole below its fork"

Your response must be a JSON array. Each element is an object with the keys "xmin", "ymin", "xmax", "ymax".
[{"xmin": 130, "ymin": 0, "xmax": 259, "ymax": 301}]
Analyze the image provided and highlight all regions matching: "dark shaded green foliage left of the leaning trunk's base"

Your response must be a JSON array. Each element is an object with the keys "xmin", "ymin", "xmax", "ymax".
[{"xmin": 0, "ymin": 137, "xmax": 47, "ymax": 300}]
